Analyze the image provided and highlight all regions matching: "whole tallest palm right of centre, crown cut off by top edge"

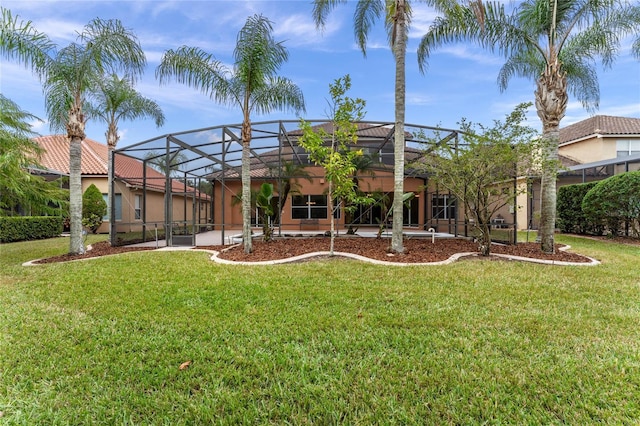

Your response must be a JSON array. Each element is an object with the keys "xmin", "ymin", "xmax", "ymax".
[{"xmin": 313, "ymin": 0, "xmax": 472, "ymax": 253}]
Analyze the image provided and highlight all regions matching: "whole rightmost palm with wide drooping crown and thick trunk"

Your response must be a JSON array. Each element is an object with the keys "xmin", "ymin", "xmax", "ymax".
[{"xmin": 418, "ymin": 0, "xmax": 640, "ymax": 253}]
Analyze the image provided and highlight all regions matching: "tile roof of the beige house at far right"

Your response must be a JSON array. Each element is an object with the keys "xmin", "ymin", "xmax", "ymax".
[{"xmin": 560, "ymin": 115, "xmax": 640, "ymax": 144}]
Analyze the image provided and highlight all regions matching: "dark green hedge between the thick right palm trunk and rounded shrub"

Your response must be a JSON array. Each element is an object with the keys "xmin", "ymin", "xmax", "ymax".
[{"xmin": 557, "ymin": 182, "xmax": 603, "ymax": 235}]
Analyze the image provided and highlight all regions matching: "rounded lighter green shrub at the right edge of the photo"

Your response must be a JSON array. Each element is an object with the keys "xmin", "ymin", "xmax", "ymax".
[{"xmin": 582, "ymin": 171, "xmax": 640, "ymax": 236}]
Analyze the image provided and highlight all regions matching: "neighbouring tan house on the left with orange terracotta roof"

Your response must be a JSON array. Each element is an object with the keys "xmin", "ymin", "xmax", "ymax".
[{"xmin": 34, "ymin": 135, "xmax": 211, "ymax": 233}]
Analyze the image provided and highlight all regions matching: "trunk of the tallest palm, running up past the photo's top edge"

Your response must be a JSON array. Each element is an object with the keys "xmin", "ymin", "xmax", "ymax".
[{"xmin": 391, "ymin": 0, "xmax": 407, "ymax": 253}]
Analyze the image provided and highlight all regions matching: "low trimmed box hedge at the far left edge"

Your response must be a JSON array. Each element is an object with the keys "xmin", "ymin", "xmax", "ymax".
[{"xmin": 0, "ymin": 216, "xmax": 62, "ymax": 243}]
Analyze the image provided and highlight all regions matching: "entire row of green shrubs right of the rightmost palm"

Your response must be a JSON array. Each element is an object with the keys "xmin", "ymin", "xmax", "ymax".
[{"xmin": 557, "ymin": 171, "xmax": 640, "ymax": 235}]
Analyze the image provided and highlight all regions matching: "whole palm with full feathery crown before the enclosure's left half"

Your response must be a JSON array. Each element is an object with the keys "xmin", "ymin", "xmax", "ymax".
[{"xmin": 156, "ymin": 15, "xmax": 305, "ymax": 253}]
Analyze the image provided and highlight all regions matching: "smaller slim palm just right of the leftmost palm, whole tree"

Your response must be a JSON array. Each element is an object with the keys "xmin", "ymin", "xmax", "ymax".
[{"xmin": 87, "ymin": 74, "xmax": 164, "ymax": 241}]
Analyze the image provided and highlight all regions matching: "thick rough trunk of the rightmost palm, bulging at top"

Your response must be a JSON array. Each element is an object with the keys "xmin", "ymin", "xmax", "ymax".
[{"xmin": 535, "ymin": 63, "xmax": 568, "ymax": 253}]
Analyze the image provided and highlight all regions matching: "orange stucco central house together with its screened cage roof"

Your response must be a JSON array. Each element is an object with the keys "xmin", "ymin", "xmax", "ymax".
[{"xmin": 115, "ymin": 120, "xmax": 476, "ymax": 245}]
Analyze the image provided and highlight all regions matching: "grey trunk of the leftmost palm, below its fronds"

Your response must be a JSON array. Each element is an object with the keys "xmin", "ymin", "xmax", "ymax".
[{"xmin": 69, "ymin": 136, "xmax": 85, "ymax": 254}]
